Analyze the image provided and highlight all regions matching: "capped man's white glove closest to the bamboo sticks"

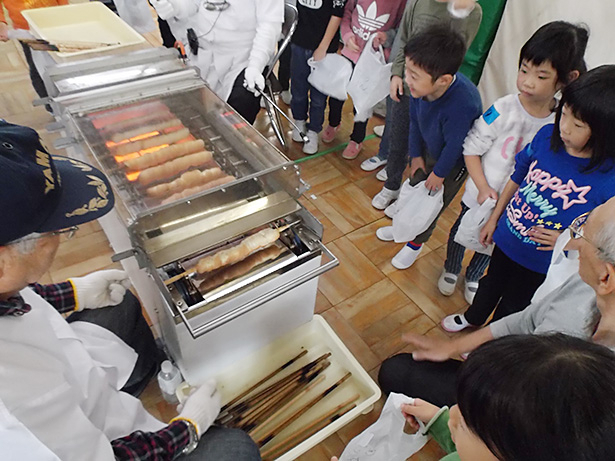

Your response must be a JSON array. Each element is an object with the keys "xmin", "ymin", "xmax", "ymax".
[{"xmin": 177, "ymin": 379, "xmax": 222, "ymax": 437}]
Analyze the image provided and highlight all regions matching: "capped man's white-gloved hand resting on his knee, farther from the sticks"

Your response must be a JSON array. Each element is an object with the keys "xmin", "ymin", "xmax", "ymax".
[{"xmin": 69, "ymin": 269, "xmax": 130, "ymax": 311}]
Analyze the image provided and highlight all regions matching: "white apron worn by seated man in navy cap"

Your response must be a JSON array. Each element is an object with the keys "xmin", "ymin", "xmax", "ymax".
[{"xmin": 0, "ymin": 288, "xmax": 164, "ymax": 461}]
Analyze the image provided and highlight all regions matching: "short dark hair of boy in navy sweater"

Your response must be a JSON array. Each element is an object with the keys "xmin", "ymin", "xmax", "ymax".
[{"xmin": 404, "ymin": 24, "xmax": 466, "ymax": 82}]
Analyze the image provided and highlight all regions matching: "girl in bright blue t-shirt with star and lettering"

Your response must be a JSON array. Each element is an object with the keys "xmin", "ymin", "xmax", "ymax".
[{"xmin": 448, "ymin": 65, "xmax": 615, "ymax": 329}]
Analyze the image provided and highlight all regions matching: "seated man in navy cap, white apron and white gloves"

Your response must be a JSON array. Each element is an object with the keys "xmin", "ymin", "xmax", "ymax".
[{"xmin": 0, "ymin": 120, "xmax": 260, "ymax": 461}]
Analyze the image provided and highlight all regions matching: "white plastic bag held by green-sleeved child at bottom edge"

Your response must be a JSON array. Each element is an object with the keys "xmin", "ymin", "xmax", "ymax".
[{"xmin": 339, "ymin": 392, "xmax": 429, "ymax": 461}]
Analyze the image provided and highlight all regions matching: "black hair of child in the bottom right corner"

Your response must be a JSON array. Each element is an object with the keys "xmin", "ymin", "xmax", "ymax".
[{"xmin": 457, "ymin": 334, "xmax": 615, "ymax": 461}]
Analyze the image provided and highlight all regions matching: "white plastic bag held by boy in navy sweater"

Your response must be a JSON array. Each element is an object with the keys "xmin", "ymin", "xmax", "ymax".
[{"xmin": 393, "ymin": 180, "xmax": 444, "ymax": 243}]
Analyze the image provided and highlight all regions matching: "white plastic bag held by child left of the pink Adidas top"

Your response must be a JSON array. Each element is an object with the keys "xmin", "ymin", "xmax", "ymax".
[{"xmin": 308, "ymin": 53, "xmax": 352, "ymax": 101}]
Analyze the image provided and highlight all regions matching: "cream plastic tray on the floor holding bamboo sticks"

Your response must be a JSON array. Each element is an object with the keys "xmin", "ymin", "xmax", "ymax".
[{"xmin": 216, "ymin": 315, "xmax": 381, "ymax": 461}]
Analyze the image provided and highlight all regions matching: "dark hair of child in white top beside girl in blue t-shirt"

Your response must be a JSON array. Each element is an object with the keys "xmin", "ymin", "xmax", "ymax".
[{"xmin": 519, "ymin": 21, "xmax": 589, "ymax": 85}]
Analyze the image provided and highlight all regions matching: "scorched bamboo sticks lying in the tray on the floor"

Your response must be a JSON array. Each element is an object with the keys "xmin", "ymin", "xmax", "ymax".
[{"xmin": 216, "ymin": 350, "xmax": 359, "ymax": 460}]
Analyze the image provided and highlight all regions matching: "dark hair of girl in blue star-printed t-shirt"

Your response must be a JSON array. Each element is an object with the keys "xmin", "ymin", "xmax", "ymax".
[{"xmin": 551, "ymin": 64, "xmax": 615, "ymax": 171}]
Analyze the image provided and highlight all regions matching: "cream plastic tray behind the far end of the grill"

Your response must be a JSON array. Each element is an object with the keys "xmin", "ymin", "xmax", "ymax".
[{"xmin": 22, "ymin": 2, "xmax": 145, "ymax": 59}]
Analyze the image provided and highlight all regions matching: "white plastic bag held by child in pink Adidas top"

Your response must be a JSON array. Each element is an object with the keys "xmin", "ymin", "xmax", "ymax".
[{"xmin": 348, "ymin": 34, "xmax": 393, "ymax": 122}]
